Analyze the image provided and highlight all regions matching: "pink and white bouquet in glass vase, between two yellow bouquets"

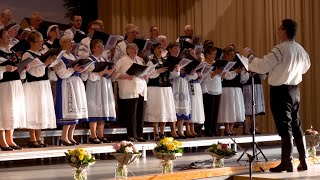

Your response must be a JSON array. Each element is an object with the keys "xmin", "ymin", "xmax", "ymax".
[{"xmin": 111, "ymin": 141, "xmax": 141, "ymax": 179}]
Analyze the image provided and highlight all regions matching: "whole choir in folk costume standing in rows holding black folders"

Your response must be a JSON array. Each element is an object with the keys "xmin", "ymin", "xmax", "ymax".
[{"xmin": 0, "ymin": 9, "xmax": 265, "ymax": 151}]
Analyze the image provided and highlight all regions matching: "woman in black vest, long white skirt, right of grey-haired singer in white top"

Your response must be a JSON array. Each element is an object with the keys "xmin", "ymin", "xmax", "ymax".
[{"xmin": 146, "ymin": 43, "xmax": 177, "ymax": 141}]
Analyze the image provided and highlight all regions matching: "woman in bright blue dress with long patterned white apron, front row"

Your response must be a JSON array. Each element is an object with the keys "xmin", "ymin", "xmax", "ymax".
[{"xmin": 53, "ymin": 35, "xmax": 88, "ymax": 146}]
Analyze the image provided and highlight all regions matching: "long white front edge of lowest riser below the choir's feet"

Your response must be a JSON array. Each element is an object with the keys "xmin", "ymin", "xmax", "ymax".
[{"xmin": 0, "ymin": 135, "xmax": 280, "ymax": 161}]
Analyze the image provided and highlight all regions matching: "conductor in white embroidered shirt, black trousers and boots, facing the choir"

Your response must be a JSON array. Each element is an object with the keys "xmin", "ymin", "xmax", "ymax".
[{"xmin": 241, "ymin": 19, "xmax": 311, "ymax": 172}]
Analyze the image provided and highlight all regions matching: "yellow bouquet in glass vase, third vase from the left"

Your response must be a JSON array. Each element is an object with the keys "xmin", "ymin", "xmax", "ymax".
[{"xmin": 153, "ymin": 137, "xmax": 183, "ymax": 174}]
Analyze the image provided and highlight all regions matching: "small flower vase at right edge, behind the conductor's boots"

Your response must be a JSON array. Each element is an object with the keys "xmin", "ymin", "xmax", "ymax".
[{"xmin": 305, "ymin": 126, "xmax": 320, "ymax": 157}]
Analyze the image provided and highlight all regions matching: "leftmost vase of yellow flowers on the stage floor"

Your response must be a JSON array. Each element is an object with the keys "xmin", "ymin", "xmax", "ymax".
[{"xmin": 64, "ymin": 148, "xmax": 96, "ymax": 180}]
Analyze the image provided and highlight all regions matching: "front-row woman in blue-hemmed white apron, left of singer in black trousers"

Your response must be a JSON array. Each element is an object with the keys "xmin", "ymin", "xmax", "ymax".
[{"xmin": 86, "ymin": 39, "xmax": 116, "ymax": 144}]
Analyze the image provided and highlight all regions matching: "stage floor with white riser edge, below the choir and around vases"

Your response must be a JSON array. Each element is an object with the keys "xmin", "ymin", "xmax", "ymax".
[{"xmin": 0, "ymin": 135, "xmax": 320, "ymax": 180}]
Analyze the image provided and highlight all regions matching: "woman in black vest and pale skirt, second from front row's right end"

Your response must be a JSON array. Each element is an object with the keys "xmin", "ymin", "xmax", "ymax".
[{"xmin": 218, "ymin": 46, "xmax": 249, "ymax": 135}]
